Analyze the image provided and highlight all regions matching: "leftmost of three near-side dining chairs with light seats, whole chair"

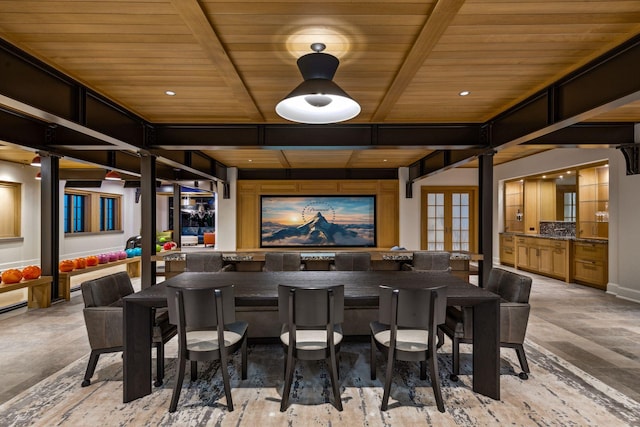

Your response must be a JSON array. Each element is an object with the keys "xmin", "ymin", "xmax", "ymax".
[{"xmin": 167, "ymin": 286, "xmax": 248, "ymax": 412}]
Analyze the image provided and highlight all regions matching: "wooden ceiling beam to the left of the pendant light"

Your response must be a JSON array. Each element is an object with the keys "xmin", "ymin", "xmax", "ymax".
[{"xmin": 171, "ymin": 0, "xmax": 264, "ymax": 122}]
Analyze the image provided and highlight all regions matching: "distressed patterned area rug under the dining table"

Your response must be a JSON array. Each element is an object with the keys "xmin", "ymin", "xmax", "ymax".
[{"xmin": 0, "ymin": 340, "xmax": 640, "ymax": 427}]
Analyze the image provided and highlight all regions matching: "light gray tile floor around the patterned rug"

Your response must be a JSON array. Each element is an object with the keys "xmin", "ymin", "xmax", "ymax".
[{"xmin": 0, "ymin": 270, "xmax": 640, "ymax": 403}]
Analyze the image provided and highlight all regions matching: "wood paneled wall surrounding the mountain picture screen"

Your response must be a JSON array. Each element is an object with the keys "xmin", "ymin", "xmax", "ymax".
[{"xmin": 237, "ymin": 180, "xmax": 400, "ymax": 250}]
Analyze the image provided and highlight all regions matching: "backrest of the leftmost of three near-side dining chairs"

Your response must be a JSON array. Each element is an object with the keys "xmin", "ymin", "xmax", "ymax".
[{"xmin": 167, "ymin": 286, "xmax": 236, "ymax": 329}]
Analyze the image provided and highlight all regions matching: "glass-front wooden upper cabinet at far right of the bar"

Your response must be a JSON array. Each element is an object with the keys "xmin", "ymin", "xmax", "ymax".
[{"xmin": 576, "ymin": 165, "xmax": 609, "ymax": 239}]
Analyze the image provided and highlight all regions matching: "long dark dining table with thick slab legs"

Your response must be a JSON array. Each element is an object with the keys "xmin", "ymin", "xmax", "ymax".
[{"xmin": 123, "ymin": 271, "xmax": 500, "ymax": 403}]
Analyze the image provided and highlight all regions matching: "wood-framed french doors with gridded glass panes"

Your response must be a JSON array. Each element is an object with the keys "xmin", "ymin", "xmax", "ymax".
[{"xmin": 420, "ymin": 187, "xmax": 478, "ymax": 252}]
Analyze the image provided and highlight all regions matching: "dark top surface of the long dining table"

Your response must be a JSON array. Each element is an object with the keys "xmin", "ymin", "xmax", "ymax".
[{"xmin": 125, "ymin": 271, "xmax": 499, "ymax": 307}]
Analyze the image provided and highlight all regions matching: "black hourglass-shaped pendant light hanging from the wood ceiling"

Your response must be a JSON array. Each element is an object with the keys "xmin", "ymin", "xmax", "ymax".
[{"xmin": 276, "ymin": 43, "xmax": 360, "ymax": 124}]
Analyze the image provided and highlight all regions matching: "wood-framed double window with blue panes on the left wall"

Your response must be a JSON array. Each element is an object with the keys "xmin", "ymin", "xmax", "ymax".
[{"xmin": 62, "ymin": 190, "xmax": 122, "ymax": 234}]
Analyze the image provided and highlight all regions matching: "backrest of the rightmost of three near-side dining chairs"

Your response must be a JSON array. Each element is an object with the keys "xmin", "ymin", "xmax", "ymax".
[{"xmin": 378, "ymin": 285, "xmax": 447, "ymax": 329}]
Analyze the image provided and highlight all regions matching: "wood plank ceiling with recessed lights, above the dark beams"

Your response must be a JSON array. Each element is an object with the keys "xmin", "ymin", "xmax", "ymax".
[{"xmin": 0, "ymin": 0, "xmax": 640, "ymax": 168}]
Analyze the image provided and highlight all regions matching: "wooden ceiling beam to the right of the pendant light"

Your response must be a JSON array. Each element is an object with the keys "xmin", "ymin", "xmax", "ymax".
[{"xmin": 371, "ymin": 0, "xmax": 465, "ymax": 122}]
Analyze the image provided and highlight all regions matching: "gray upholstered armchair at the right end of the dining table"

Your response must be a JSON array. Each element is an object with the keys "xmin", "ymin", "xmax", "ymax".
[{"xmin": 440, "ymin": 267, "xmax": 531, "ymax": 381}]
